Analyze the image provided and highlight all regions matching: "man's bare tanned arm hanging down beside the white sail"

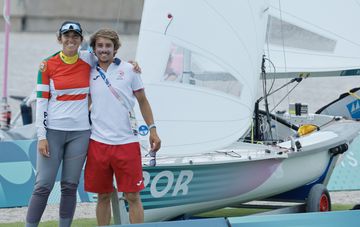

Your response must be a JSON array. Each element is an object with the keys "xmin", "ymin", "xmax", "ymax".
[{"xmin": 134, "ymin": 90, "xmax": 161, "ymax": 152}]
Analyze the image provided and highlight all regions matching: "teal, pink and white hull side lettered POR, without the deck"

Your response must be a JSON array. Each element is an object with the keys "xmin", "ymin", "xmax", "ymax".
[{"xmin": 141, "ymin": 145, "xmax": 333, "ymax": 221}]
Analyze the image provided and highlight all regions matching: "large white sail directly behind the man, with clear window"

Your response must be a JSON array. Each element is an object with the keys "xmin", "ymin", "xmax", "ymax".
[{"xmin": 137, "ymin": 0, "xmax": 268, "ymax": 155}]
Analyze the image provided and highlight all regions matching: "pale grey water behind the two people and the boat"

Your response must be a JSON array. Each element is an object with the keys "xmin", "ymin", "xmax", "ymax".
[{"xmin": 0, "ymin": 33, "xmax": 360, "ymax": 116}]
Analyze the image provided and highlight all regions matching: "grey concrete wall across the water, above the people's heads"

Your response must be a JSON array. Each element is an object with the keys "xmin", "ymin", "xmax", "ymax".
[{"xmin": 0, "ymin": 0, "xmax": 144, "ymax": 34}]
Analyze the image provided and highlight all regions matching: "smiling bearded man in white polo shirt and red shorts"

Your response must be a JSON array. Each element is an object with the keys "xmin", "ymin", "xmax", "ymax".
[{"xmin": 85, "ymin": 29, "xmax": 161, "ymax": 226}]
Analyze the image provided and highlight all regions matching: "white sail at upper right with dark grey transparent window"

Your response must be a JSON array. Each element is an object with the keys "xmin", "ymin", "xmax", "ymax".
[{"xmin": 264, "ymin": 0, "xmax": 360, "ymax": 77}]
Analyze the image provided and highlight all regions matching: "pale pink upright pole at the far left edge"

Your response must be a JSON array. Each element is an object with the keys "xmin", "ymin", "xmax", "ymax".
[{"xmin": 0, "ymin": 0, "xmax": 11, "ymax": 129}]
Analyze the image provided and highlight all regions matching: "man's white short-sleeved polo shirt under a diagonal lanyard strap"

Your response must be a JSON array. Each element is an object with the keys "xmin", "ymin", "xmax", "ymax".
[{"xmin": 90, "ymin": 59, "xmax": 144, "ymax": 145}]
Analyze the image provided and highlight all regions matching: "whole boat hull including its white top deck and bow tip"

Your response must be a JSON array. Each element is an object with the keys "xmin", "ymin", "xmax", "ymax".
[{"xmin": 134, "ymin": 118, "xmax": 359, "ymax": 222}]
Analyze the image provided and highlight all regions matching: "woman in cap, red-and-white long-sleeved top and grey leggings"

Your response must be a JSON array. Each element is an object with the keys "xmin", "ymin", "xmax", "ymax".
[{"xmin": 26, "ymin": 21, "xmax": 91, "ymax": 227}]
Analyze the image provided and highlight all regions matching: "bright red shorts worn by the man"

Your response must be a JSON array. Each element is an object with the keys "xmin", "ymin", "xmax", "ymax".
[{"xmin": 85, "ymin": 140, "xmax": 144, "ymax": 193}]
